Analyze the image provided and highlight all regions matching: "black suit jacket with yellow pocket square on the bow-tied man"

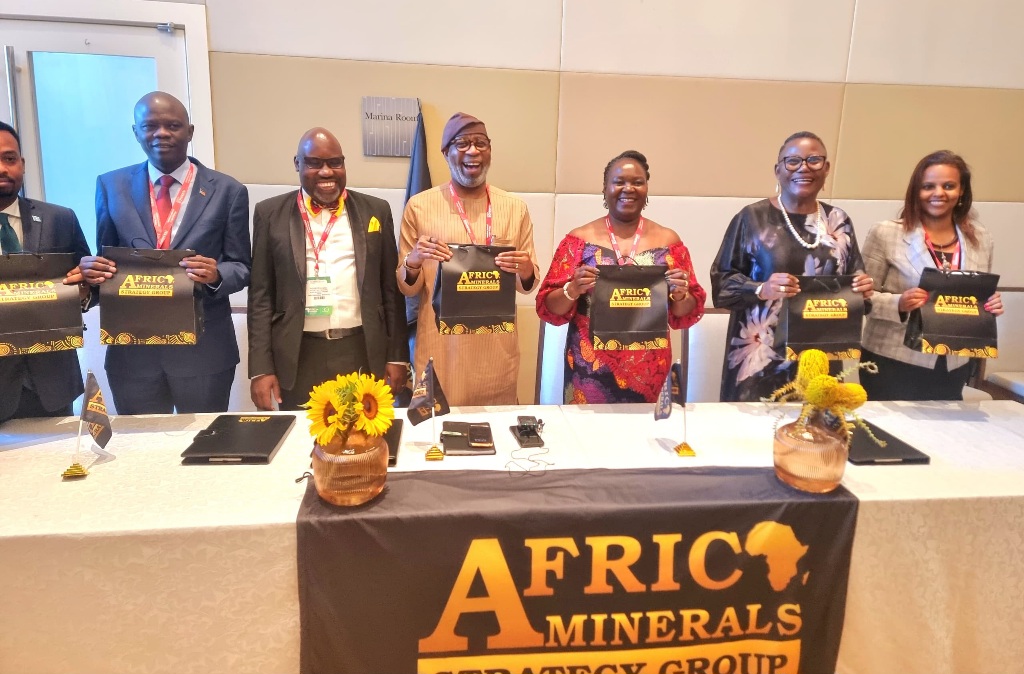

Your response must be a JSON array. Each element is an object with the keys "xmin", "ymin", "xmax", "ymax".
[{"xmin": 249, "ymin": 191, "xmax": 409, "ymax": 390}]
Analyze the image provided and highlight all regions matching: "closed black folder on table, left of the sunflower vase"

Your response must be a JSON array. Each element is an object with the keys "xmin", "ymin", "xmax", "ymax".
[{"xmin": 181, "ymin": 414, "xmax": 295, "ymax": 465}]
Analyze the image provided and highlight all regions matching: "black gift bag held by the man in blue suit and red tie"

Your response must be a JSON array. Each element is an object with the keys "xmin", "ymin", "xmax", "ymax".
[{"xmin": 99, "ymin": 246, "xmax": 203, "ymax": 346}]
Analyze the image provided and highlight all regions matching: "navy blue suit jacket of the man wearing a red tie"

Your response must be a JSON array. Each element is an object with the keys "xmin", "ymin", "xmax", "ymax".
[{"xmin": 96, "ymin": 159, "xmax": 252, "ymax": 377}]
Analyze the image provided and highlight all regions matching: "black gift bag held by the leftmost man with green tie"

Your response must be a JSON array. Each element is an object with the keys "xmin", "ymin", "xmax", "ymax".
[{"xmin": 0, "ymin": 253, "xmax": 84, "ymax": 356}]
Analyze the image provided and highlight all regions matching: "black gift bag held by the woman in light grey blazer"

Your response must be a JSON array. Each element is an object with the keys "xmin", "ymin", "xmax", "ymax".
[{"xmin": 903, "ymin": 267, "xmax": 999, "ymax": 359}]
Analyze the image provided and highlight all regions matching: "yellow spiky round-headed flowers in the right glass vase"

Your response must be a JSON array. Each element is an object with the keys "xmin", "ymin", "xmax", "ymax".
[{"xmin": 763, "ymin": 348, "xmax": 885, "ymax": 440}]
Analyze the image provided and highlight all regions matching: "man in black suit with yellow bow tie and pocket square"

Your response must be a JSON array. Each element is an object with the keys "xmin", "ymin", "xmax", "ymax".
[{"xmin": 249, "ymin": 128, "xmax": 409, "ymax": 410}]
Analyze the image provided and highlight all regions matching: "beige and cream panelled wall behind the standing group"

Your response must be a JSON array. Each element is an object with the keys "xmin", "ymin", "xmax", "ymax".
[{"xmin": 199, "ymin": 0, "xmax": 1024, "ymax": 399}]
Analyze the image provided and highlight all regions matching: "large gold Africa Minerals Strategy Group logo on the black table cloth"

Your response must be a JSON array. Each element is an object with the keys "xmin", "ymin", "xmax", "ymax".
[{"xmin": 418, "ymin": 521, "xmax": 815, "ymax": 674}]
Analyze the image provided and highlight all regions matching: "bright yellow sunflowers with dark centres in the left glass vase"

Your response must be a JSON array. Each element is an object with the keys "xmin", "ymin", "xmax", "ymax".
[{"xmin": 303, "ymin": 373, "xmax": 394, "ymax": 445}]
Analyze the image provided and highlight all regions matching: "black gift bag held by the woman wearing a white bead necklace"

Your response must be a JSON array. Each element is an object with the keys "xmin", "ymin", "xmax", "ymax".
[{"xmin": 774, "ymin": 275, "xmax": 864, "ymax": 361}]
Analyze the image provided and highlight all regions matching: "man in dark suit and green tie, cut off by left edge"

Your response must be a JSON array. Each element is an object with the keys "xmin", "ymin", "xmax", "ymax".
[{"xmin": 0, "ymin": 122, "xmax": 89, "ymax": 423}]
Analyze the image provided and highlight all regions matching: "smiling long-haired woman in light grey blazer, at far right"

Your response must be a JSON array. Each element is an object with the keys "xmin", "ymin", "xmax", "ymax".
[{"xmin": 860, "ymin": 150, "xmax": 1002, "ymax": 401}]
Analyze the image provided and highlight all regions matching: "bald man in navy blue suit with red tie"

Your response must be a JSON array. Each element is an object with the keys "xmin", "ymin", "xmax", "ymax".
[{"xmin": 82, "ymin": 91, "xmax": 252, "ymax": 414}]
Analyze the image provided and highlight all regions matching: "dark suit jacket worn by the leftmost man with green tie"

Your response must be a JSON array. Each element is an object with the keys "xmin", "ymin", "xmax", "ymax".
[{"xmin": 0, "ymin": 199, "xmax": 90, "ymax": 420}]
